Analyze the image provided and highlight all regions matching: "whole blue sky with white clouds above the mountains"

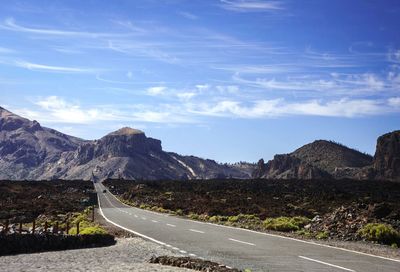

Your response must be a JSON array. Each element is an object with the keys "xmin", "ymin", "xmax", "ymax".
[{"xmin": 0, "ymin": 0, "xmax": 400, "ymax": 162}]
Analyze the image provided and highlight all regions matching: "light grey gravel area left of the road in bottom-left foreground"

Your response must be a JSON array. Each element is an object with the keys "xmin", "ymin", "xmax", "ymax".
[{"xmin": 0, "ymin": 238, "xmax": 193, "ymax": 272}]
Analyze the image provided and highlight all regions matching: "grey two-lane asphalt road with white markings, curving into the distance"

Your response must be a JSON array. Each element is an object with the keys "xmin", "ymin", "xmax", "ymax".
[{"xmin": 95, "ymin": 183, "xmax": 400, "ymax": 272}]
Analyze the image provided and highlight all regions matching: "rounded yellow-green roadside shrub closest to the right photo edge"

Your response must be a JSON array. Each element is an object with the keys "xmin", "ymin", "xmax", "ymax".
[{"xmin": 358, "ymin": 223, "xmax": 400, "ymax": 245}]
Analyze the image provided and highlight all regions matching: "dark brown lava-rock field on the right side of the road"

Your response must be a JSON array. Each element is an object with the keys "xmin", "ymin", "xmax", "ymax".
[{"xmin": 105, "ymin": 179, "xmax": 400, "ymax": 243}]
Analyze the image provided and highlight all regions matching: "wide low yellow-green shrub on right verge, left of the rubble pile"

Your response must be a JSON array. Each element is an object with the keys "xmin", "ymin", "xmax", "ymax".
[{"xmin": 264, "ymin": 216, "xmax": 310, "ymax": 232}]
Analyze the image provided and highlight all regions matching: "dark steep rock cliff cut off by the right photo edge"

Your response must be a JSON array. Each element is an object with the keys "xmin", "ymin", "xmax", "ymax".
[{"xmin": 374, "ymin": 130, "xmax": 400, "ymax": 181}]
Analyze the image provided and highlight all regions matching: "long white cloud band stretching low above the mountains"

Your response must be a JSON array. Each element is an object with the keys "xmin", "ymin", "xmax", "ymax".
[{"xmin": 16, "ymin": 96, "xmax": 400, "ymax": 127}]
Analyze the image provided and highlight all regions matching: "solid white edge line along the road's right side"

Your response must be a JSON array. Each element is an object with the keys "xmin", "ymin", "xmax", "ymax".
[{"xmin": 102, "ymin": 185, "xmax": 400, "ymax": 263}]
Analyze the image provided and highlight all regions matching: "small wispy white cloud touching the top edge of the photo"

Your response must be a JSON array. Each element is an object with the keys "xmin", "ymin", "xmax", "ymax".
[{"xmin": 220, "ymin": 0, "xmax": 284, "ymax": 12}]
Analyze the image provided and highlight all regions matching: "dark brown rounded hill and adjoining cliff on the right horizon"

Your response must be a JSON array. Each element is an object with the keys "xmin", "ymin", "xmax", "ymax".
[{"xmin": 253, "ymin": 131, "xmax": 400, "ymax": 181}]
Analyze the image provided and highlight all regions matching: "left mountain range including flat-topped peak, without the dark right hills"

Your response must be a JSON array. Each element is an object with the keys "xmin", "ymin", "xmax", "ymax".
[{"xmin": 0, "ymin": 108, "xmax": 249, "ymax": 180}]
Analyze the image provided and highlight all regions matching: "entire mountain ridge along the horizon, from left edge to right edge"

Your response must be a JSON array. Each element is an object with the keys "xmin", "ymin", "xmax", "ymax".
[{"xmin": 0, "ymin": 107, "xmax": 400, "ymax": 181}]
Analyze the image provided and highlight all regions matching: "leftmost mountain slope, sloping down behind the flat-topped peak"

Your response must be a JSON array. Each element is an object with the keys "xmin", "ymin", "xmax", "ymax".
[{"xmin": 0, "ymin": 108, "xmax": 84, "ymax": 180}]
